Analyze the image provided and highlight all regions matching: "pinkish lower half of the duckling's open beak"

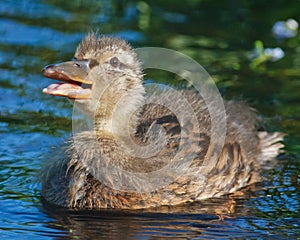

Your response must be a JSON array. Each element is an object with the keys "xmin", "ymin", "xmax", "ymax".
[{"xmin": 43, "ymin": 83, "xmax": 91, "ymax": 99}]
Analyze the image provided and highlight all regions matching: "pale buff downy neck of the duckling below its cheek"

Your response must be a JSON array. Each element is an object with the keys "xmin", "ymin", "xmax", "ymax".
[{"xmin": 94, "ymin": 81, "xmax": 145, "ymax": 138}]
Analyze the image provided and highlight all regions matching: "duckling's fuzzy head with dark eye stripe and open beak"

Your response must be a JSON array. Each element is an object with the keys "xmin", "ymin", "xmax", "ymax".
[{"xmin": 43, "ymin": 33, "xmax": 145, "ymax": 124}]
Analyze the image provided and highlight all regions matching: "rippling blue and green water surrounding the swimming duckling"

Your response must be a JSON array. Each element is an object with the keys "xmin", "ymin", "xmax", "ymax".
[{"xmin": 0, "ymin": 0, "xmax": 300, "ymax": 240}]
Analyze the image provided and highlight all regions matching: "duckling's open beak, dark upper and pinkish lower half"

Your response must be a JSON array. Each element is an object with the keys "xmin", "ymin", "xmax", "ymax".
[{"xmin": 42, "ymin": 60, "xmax": 93, "ymax": 99}]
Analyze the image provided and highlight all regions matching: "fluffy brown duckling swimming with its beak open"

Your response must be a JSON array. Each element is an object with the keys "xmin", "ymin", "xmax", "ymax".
[{"xmin": 42, "ymin": 34, "xmax": 282, "ymax": 209}]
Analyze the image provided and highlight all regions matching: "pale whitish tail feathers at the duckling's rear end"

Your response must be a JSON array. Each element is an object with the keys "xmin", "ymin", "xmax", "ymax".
[{"xmin": 258, "ymin": 131, "xmax": 285, "ymax": 162}]
